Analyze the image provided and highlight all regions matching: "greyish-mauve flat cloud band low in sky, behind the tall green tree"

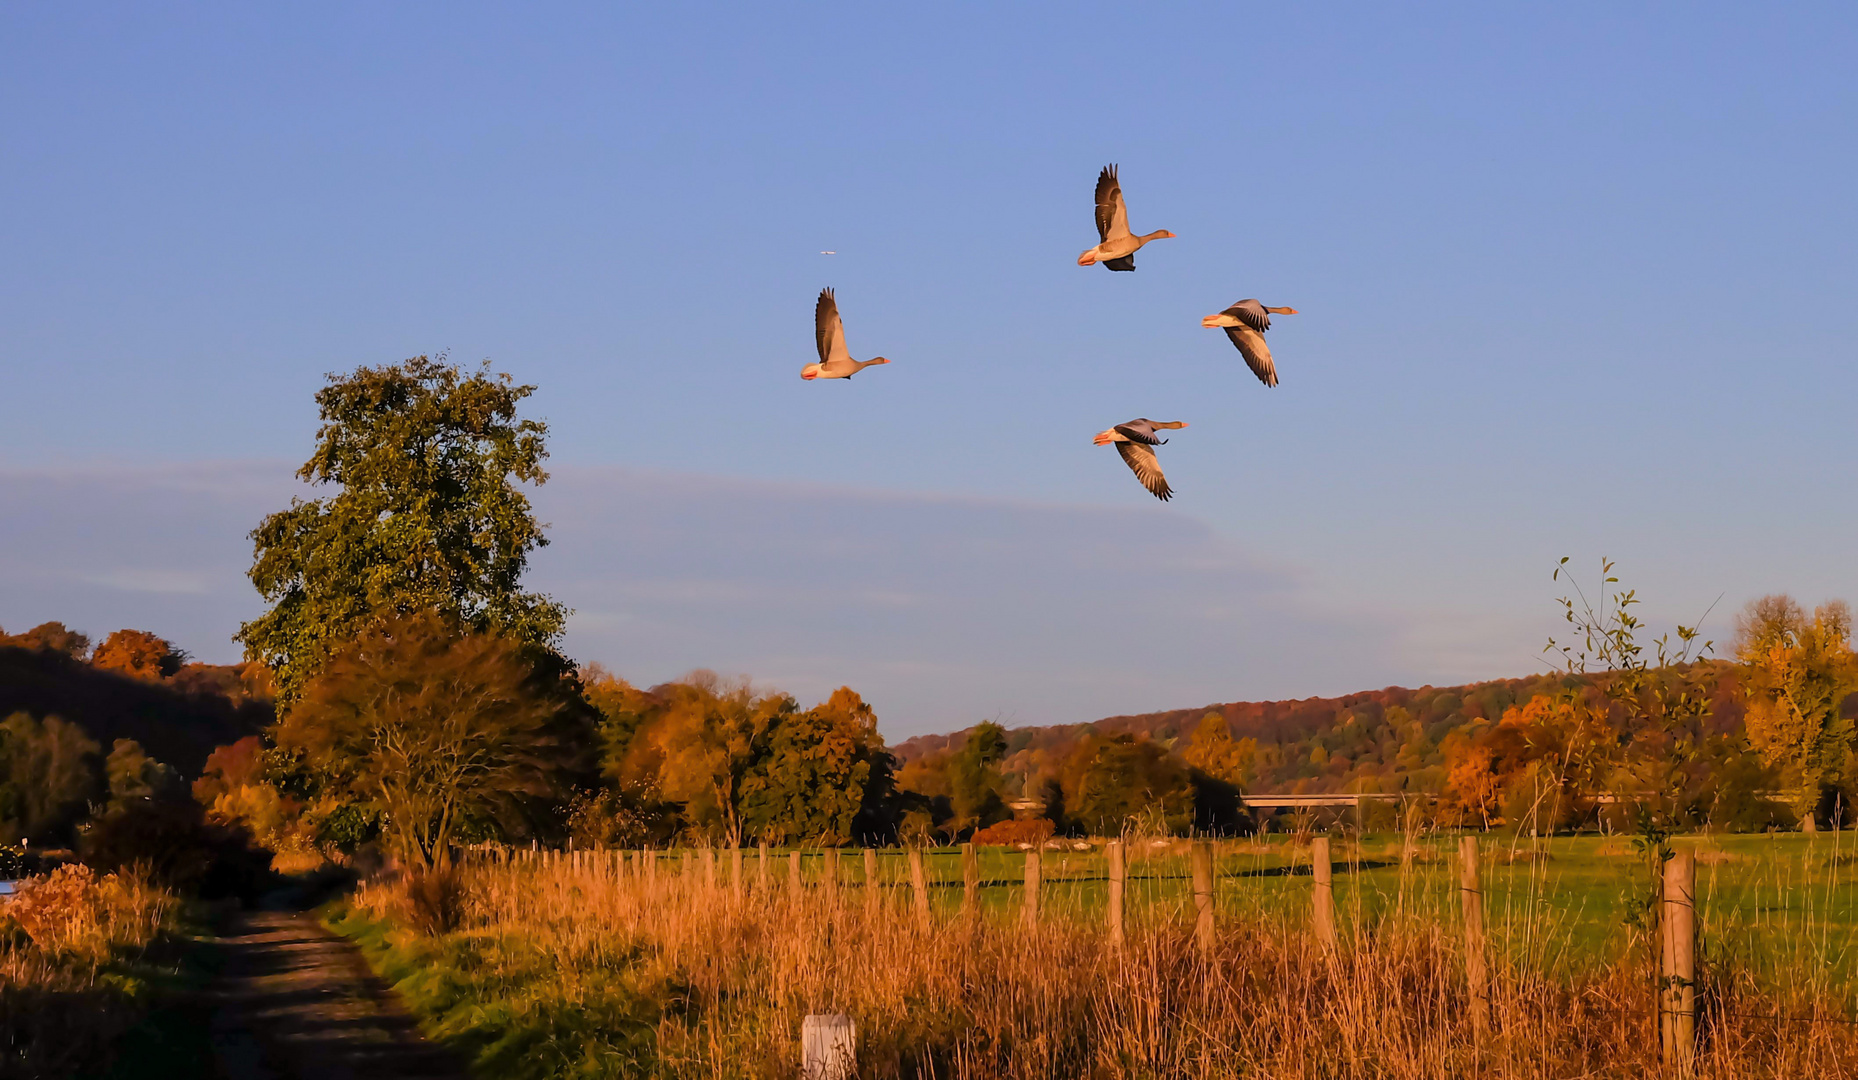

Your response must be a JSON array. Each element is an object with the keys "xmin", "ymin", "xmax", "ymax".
[{"xmin": 0, "ymin": 461, "xmax": 1395, "ymax": 736}]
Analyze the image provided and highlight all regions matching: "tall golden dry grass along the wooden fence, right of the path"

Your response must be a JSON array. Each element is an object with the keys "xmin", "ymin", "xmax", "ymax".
[{"xmin": 359, "ymin": 857, "xmax": 1858, "ymax": 1080}]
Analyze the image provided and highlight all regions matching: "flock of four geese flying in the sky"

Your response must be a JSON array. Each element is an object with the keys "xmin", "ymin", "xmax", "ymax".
[{"xmin": 801, "ymin": 165, "xmax": 1297, "ymax": 502}]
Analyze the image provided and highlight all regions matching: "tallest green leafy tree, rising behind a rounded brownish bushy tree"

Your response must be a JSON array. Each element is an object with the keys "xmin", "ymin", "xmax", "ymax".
[{"xmin": 238, "ymin": 357, "xmax": 567, "ymax": 706}]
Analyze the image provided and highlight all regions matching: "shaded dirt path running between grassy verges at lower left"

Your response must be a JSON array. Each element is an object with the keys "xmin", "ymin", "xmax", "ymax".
[{"xmin": 212, "ymin": 911, "xmax": 465, "ymax": 1080}]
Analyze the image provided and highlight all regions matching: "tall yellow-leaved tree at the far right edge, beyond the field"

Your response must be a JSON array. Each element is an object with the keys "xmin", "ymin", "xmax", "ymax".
[{"xmin": 1735, "ymin": 595, "xmax": 1858, "ymax": 822}]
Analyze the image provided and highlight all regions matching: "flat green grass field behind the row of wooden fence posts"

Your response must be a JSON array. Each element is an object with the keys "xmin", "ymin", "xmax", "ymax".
[{"xmin": 745, "ymin": 833, "xmax": 1858, "ymax": 978}]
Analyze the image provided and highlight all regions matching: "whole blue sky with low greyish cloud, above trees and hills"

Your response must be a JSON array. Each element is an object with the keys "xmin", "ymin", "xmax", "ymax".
[{"xmin": 0, "ymin": 4, "xmax": 1858, "ymax": 734}]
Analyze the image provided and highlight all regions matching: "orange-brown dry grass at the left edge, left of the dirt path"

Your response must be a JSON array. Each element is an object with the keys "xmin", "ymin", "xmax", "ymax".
[{"xmin": 0, "ymin": 866, "xmax": 175, "ymax": 1076}]
